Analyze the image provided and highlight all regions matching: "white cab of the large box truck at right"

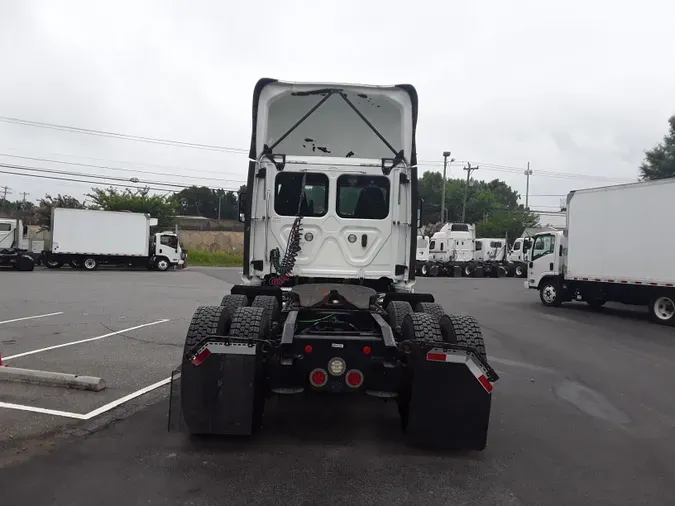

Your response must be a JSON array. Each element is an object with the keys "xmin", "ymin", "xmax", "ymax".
[{"xmin": 525, "ymin": 231, "xmax": 565, "ymax": 301}]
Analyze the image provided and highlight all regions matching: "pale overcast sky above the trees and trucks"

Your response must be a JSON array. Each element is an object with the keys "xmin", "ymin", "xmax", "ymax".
[{"xmin": 0, "ymin": 0, "xmax": 675, "ymax": 210}]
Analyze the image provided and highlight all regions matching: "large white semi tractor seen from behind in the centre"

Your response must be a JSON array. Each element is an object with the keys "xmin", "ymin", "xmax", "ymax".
[{"xmin": 169, "ymin": 79, "xmax": 498, "ymax": 450}]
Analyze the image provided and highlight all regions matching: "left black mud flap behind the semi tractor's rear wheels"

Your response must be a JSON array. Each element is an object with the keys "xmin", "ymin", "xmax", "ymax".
[{"xmin": 168, "ymin": 346, "xmax": 264, "ymax": 436}]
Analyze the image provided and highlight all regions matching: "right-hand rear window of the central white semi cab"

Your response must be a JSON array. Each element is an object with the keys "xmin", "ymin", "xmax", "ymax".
[{"xmin": 337, "ymin": 174, "xmax": 389, "ymax": 220}]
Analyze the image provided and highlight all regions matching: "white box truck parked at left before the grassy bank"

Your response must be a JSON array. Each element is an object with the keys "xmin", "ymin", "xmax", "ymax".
[{"xmin": 42, "ymin": 208, "xmax": 185, "ymax": 271}]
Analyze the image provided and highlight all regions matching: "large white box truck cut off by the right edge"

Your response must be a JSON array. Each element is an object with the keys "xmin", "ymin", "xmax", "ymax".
[{"xmin": 525, "ymin": 178, "xmax": 675, "ymax": 325}]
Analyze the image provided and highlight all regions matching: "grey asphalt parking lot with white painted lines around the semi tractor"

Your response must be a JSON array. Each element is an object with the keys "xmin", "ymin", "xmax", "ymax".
[{"xmin": 0, "ymin": 268, "xmax": 675, "ymax": 506}]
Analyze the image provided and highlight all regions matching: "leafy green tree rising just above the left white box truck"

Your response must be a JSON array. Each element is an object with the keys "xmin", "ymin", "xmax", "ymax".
[{"xmin": 87, "ymin": 187, "xmax": 180, "ymax": 227}]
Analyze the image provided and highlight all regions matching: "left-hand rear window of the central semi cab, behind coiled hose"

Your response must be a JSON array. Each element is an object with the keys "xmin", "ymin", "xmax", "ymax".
[{"xmin": 274, "ymin": 172, "xmax": 328, "ymax": 216}]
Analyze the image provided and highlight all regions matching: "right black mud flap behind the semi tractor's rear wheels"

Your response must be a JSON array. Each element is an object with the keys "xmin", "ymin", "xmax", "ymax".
[{"xmin": 406, "ymin": 348, "xmax": 492, "ymax": 450}]
